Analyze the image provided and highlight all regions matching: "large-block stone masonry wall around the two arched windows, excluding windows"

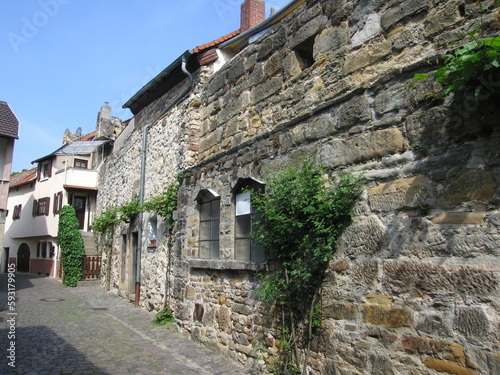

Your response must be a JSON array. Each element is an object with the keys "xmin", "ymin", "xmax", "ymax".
[{"xmin": 173, "ymin": 0, "xmax": 500, "ymax": 375}]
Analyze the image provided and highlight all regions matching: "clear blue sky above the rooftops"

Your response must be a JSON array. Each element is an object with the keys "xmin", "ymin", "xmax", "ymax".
[{"xmin": 0, "ymin": 0, "xmax": 289, "ymax": 172}]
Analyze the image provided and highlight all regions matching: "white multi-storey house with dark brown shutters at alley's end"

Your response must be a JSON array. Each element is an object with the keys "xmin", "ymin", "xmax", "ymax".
[{"xmin": 4, "ymin": 106, "xmax": 119, "ymax": 277}]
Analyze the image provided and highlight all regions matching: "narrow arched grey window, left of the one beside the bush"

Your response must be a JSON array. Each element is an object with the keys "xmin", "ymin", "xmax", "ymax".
[{"xmin": 196, "ymin": 189, "xmax": 220, "ymax": 259}]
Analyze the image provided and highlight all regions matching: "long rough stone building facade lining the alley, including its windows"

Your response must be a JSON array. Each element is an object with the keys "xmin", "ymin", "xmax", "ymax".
[{"xmin": 98, "ymin": 0, "xmax": 500, "ymax": 374}]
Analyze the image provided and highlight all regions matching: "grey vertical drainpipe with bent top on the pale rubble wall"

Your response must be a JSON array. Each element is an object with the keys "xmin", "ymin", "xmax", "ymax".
[{"xmin": 135, "ymin": 51, "xmax": 193, "ymax": 307}]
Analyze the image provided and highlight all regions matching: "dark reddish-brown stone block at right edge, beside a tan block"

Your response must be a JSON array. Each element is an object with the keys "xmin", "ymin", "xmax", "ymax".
[{"xmin": 437, "ymin": 169, "xmax": 495, "ymax": 207}]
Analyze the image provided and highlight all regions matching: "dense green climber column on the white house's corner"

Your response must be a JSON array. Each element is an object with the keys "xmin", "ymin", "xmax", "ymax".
[{"xmin": 57, "ymin": 206, "xmax": 85, "ymax": 287}]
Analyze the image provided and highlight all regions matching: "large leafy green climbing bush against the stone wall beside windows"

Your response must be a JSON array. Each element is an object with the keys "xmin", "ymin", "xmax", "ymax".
[{"xmin": 251, "ymin": 160, "xmax": 361, "ymax": 374}]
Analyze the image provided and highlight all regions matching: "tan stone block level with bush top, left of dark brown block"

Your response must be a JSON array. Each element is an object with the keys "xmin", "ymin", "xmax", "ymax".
[{"xmin": 368, "ymin": 175, "xmax": 433, "ymax": 211}]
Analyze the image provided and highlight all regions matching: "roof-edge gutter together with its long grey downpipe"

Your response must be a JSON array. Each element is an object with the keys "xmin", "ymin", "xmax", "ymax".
[{"xmin": 135, "ymin": 50, "xmax": 194, "ymax": 307}]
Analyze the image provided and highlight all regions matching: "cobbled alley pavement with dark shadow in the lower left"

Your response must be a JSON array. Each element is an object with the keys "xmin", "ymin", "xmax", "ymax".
[{"xmin": 0, "ymin": 274, "xmax": 251, "ymax": 375}]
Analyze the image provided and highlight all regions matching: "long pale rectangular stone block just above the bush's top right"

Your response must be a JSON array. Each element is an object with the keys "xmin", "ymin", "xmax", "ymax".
[{"xmin": 320, "ymin": 128, "xmax": 404, "ymax": 168}]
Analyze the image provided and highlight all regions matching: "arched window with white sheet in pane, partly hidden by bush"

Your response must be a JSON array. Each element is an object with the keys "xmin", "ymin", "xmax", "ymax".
[{"xmin": 233, "ymin": 178, "xmax": 266, "ymax": 262}]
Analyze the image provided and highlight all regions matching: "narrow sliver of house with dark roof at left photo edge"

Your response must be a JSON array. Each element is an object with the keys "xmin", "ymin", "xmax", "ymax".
[{"xmin": 0, "ymin": 101, "xmax": 19, "ymax": 272}]
